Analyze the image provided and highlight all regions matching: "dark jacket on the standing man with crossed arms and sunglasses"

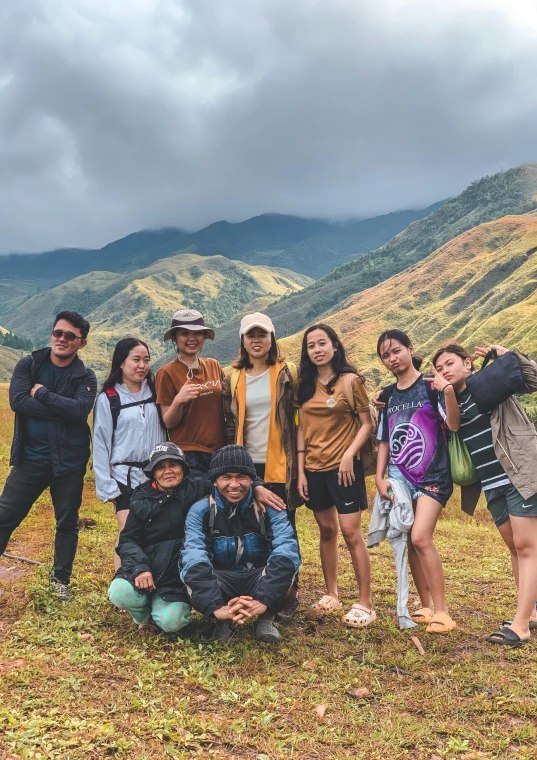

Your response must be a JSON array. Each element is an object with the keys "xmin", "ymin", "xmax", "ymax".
[{"xmin": 9, "ymin": 348, "xmax": 97, "ymax": 475}]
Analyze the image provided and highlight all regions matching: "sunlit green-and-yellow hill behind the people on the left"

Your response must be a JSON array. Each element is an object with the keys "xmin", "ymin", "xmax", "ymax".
[{"xmin": 3, "ymin": 254, "xmax": 311, "ymax": 373}]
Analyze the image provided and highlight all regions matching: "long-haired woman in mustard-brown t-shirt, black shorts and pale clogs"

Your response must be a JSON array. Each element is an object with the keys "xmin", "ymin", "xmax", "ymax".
[{"xmin": 297, "ymin": 324, "xmax": 377, "ymax": 628}]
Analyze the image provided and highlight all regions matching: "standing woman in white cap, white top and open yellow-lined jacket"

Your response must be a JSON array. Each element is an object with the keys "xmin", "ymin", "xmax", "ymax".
[{"xmin": 223, "ymin": 312, "xmax": 302, "ymax": 619}]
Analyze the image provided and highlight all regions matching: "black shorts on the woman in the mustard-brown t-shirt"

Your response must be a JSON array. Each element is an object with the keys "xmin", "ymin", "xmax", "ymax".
[{"xmin": 306, "ymin": 459, "xmax": 367, "ymax": 515}]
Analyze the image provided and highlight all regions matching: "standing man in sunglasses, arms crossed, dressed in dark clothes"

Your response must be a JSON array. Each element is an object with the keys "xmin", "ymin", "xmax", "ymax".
[{"xmin": 0, "ymin": 311, "xmax": 97, "ymax": 602}]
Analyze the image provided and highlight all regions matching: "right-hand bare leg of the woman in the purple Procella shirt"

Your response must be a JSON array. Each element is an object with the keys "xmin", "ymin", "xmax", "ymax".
[{"xmin": 409, "ymin": 496, "xmax": 448, "ymax": 613}]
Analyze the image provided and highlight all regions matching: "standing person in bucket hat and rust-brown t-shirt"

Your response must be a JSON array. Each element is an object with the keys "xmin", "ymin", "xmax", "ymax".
[{"xmin": 156, "ymin": 309, "xmax": 225, "ymax": 477}]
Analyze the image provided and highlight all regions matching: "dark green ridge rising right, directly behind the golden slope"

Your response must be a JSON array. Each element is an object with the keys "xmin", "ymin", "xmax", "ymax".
[{"xmin": 203, "ymin": 164, "xmax": 537, "ymax": 361}]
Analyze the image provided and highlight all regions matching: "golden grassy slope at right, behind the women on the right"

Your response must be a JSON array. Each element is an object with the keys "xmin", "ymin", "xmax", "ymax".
[{"xmin": 282, "ymin": 215, "xmax": 537, "ymax": 386}]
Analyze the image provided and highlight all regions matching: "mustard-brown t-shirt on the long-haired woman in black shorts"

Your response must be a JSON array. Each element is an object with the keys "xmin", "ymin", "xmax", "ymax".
[{"xmin": 302, "ymin": 377, "xmax": 369, "ymax": 472}]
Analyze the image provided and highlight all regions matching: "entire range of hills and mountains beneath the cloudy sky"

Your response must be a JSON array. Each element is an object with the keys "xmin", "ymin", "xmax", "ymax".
[{"xmin": 0, "ymin": 164, "xmax": 537, "ymax": 383}]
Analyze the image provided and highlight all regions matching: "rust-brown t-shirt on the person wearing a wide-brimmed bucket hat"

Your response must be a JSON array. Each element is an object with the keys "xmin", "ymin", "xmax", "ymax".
[{"xmin": 156, "ymin": 358, "xmax": 225, "ymax": 454}]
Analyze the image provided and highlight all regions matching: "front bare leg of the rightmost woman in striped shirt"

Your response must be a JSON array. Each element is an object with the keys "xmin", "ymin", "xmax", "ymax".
[{"xmin": 502, "ymin": 515, "xmax": 537, "ymax": 639}]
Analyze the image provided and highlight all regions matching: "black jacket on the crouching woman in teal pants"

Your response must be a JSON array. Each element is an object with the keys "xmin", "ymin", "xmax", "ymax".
[{"xmin": 115, "ymin": 477, "xmax": 213, "ymax": 602}]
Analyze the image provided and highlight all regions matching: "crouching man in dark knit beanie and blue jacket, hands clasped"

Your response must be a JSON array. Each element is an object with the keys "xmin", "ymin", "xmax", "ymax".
[{"xmin": 179, "ymin": 446, "xmax": 300, "ymax": 644}]
